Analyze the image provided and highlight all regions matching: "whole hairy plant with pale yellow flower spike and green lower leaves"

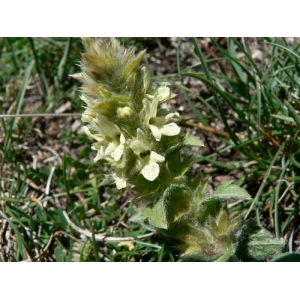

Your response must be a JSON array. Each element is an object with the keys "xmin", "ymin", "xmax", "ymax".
[{"xmin": 72, "ymin": 38, "xmax": 282, "ymax": 261}]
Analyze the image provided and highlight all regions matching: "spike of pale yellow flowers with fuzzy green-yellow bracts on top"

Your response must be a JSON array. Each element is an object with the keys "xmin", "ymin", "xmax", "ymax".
[{"xmin": 72, "ymin": 38, "xmax": 180, "ymax": 189}]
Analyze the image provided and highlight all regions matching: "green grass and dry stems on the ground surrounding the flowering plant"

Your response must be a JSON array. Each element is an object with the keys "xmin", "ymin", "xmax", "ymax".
[{"xmin": 0, "ymin": 38, "xmax": 300, "ymax": 261}]
